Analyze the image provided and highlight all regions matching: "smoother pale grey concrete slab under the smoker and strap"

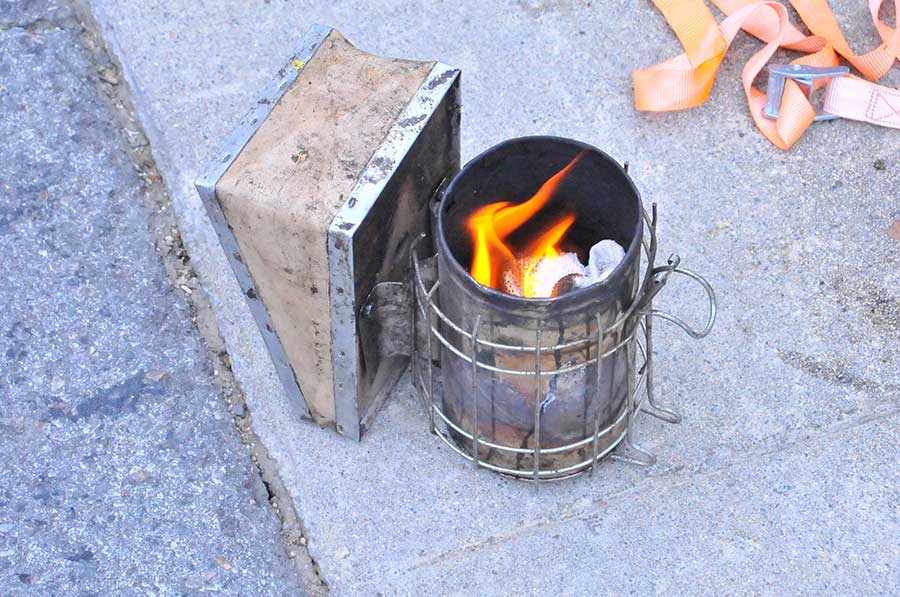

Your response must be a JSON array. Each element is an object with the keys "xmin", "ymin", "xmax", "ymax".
[{"xmin": 81, "ymin": 0, "xmax": 900, "ymax": 594}]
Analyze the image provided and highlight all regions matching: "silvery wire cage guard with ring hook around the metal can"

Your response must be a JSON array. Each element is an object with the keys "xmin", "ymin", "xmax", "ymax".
[{"xmin": 410, "ymin": 203, "xmax": 716, "ymax": 481}]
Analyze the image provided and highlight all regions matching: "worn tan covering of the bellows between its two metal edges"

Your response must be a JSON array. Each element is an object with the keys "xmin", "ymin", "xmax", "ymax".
[{"xmin": 216, "ymin": 31, "xmax": 434, "ymax": 424}]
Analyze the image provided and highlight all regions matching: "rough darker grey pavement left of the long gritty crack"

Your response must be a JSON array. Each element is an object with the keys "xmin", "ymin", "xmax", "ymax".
[{"xmin": 0, "ymin": 2, "xmax": 300, "ymax": 596}]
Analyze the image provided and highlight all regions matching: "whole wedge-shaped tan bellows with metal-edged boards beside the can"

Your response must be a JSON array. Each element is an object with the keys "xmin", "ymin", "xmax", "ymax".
[{"xmin": 196, "ymin": 25, "xmax": 460, "ymax": 439}]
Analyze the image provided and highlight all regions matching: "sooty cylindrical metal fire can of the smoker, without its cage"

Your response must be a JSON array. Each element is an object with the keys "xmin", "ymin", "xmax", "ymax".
[{"xmin": 436, "ymin": 137, "xmax": 644, "ymax": 470}]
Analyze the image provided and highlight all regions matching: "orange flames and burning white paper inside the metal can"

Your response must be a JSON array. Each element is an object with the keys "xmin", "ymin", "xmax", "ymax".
[{"xmin": 466, "ymin": 152, "xmax": 625, "ymax": 298}]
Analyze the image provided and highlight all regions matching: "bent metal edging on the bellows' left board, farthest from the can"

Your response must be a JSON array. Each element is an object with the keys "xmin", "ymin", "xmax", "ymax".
[{"xmin": 195, "ymin": 24, "xmax": 332, "ymax": 418}]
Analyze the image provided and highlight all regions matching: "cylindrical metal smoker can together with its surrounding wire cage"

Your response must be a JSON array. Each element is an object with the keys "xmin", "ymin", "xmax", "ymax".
[{"xmin": 412, "ymin": 138, "xmax": 715, "ymax": 481}]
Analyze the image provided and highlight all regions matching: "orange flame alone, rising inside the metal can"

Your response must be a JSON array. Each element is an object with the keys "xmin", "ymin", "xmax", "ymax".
[{"xmin": 466, "ymin": 153, "xmax": 584, "ymax": 297}]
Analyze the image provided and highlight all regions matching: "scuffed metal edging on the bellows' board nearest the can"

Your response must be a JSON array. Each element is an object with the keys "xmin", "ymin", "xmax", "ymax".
[{"xmin": 328, "ymin": 62, "xmax": 460, "ymax": 440}]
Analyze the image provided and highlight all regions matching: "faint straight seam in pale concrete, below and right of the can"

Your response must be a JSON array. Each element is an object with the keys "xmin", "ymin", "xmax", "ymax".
[{"xmin": 401, "ymin": 400, "xmax": 900, "ymax": 573}]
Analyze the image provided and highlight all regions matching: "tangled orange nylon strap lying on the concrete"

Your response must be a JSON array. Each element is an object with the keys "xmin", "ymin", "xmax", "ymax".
[{"xmin": 632, "ymin": 0, "xmax": 900, "ymax": 149}]
